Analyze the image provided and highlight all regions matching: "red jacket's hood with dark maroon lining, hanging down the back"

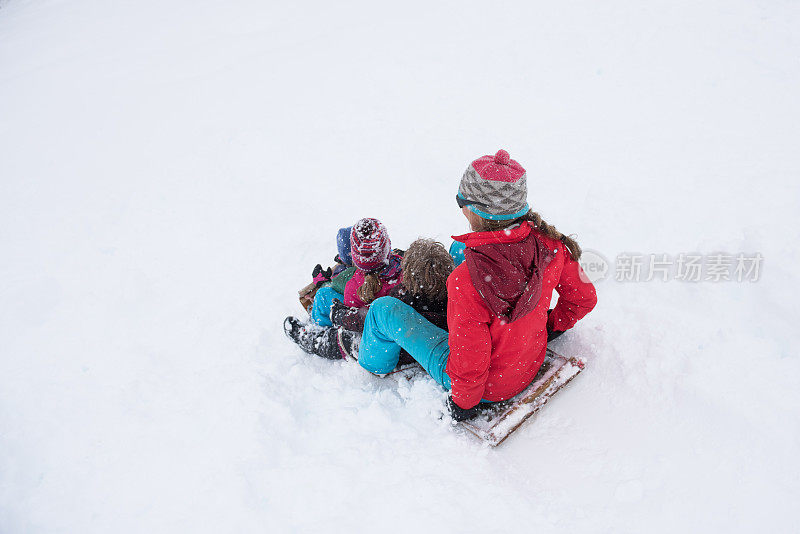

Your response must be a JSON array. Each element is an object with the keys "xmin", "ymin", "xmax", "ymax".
[{"xmin": 453, "ymin": 221, "xmax": 553, "ymax": 322}]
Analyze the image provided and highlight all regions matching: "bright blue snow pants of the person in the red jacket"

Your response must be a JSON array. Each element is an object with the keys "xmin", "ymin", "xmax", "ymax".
[{"xmin": 360, "ymin": 297, "xmax": 450, "ymax": 390}]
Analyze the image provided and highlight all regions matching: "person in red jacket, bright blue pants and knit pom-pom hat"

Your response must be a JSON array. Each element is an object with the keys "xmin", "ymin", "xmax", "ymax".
[{"xmin": 359, "ymin": 150, "xmax": 597, "ymax": 421}]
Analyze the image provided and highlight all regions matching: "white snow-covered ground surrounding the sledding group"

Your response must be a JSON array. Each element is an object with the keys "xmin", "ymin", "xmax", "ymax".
[{"xmin": 0, "ymin": 0, "xmax": 800, "ymax": 534}]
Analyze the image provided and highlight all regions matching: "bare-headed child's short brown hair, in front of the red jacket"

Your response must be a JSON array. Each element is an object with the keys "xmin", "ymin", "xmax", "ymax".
[{"xmin": 401, "ymin": 238, "xmax": 455, "ymax": 300}]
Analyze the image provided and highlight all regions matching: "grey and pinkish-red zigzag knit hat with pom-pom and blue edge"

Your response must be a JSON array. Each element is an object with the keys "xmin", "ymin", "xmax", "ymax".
[{"xmin": 456, "ymin": 149, "xmax": 530, "ymax": 221}]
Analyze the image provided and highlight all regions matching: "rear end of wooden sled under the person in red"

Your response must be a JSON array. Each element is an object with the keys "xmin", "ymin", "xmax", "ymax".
[{"xmin": 459, "ymin": 349, "xmax": 586, "ymax": 447}]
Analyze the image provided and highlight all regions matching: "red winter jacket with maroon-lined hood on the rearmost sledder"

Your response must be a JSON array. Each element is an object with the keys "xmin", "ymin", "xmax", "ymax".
[{"xmin": 446, "ymin": 222, "xmax": 597, "ymax": 409}]
